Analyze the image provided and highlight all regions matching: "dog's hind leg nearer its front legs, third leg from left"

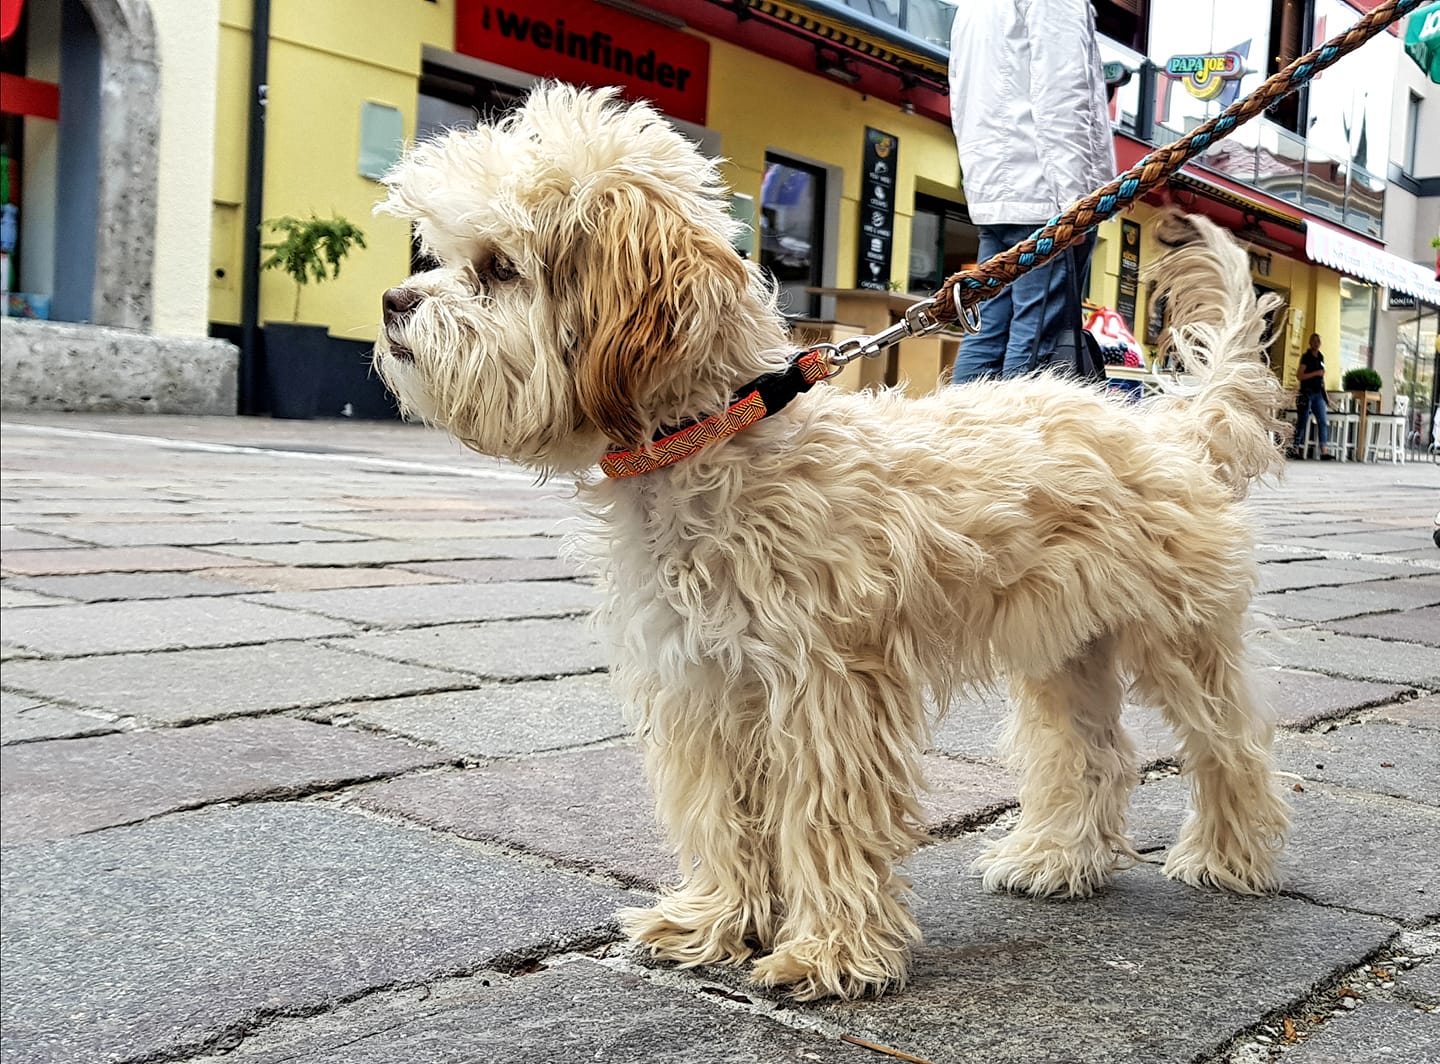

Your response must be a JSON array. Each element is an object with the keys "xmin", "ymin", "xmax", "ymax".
[{"xmin": 975, "ymin": 636, "xmax": 1139, "ymax": 897}]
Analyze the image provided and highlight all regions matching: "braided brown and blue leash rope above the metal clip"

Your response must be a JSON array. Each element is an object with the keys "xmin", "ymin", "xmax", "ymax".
[{"xmin": 929, "ymin": 0, "xmax": 1424, "ymax": 321}]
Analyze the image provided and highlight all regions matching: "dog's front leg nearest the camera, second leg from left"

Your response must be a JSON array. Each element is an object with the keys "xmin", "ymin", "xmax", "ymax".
[{"xmin": 753, "ymin": 665, "xmax": 926, "ymax": 1001}]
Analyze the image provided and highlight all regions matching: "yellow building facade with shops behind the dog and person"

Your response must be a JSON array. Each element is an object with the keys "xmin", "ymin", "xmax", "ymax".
[{"xmin": 210, "ymin": 0, "xmax": 1341, "ymax": 408}]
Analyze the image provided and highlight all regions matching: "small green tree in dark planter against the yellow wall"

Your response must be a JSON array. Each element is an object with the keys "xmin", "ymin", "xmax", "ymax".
[{"xmin": 261, "ymin": 215, "xmax": 366, "ymax": 418}]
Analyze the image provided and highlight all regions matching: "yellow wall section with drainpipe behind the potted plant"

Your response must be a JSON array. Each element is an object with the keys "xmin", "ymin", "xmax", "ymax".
[{"xmin": 210, "ymin": 0, "xmax": 455, "ymax": 331}]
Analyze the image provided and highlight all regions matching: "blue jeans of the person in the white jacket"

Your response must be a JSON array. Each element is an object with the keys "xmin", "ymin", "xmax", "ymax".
[{"xmin": 950, "ymin": 226, "xmax": 1094, "ymax": 384}]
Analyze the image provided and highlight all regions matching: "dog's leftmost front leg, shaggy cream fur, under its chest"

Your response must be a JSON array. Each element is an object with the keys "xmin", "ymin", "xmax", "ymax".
[{"xmin": 619, "ymin": 695, "xmax": 776, "ymax": 966}]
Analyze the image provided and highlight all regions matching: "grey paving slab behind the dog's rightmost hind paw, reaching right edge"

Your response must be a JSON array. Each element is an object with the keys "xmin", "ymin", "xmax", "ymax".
[{"xmin": 1130, "ymin": 777, "xmax": 1440, "ymax": 923}]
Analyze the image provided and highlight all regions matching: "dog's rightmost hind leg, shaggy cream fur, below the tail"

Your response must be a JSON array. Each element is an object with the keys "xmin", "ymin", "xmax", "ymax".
[{"xmin": 1136, "ymin": 621, "xmax": 1290, "ymax": 894}]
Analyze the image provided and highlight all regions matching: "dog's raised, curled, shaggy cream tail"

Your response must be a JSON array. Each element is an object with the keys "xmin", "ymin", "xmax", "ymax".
[{"xmin": 1149, "ymin": 210, "xmax": 1286, "ymax": 498}]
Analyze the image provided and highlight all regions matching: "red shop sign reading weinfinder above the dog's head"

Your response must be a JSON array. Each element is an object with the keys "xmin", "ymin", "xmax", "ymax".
[{"xmin": 455, "ymin": 0, "xmax": 710, "ymax": 125}]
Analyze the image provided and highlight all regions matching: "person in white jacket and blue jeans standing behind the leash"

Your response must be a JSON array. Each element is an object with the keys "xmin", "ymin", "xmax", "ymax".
[{"xmin": 950, "ymin": 0, "xmax": 1115, "ymax": 383}]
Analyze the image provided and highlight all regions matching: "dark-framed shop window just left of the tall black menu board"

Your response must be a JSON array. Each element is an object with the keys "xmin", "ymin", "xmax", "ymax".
[{"xmin": 760, "ymin": 154, "xmax": 825, "ymax": 318}]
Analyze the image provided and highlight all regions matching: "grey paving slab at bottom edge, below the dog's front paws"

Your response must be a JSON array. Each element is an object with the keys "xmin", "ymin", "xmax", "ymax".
[{"xmin": 181, "ymin": 960, "xmax": 883, "ymax": 1064}]
